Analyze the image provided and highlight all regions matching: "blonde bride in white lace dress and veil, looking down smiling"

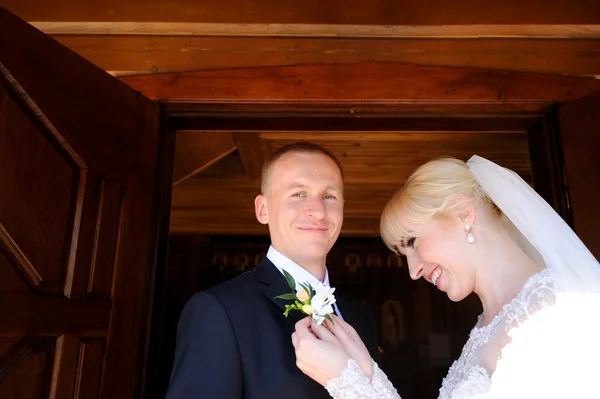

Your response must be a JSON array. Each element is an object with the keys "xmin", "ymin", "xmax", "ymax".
[{"xmin": 292, "ymin": 156, "xmax": 600, "ymax": 399}]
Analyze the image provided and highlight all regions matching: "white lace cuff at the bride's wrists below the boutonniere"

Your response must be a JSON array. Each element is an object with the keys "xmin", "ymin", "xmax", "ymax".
[{"xmin": 325, "ymin": 359, "xmax": 401, "ymax": 399}]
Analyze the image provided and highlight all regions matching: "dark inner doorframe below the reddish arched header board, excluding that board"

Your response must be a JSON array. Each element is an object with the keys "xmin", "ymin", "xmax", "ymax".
[{"xmin": 142, "ymin": 104, "xmax": 571, "ymax": 399}]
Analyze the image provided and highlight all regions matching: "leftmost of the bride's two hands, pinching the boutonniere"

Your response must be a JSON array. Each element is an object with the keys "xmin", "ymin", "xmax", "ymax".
[{"xmin": 292, "ymin": 317, "xmax": 350, "ymax": 386}]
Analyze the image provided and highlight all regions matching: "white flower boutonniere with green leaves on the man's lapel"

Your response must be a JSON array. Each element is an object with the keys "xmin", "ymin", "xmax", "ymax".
[{"xmin": 275, "ymin": 270, "xmax": 335, "ymax": 325}]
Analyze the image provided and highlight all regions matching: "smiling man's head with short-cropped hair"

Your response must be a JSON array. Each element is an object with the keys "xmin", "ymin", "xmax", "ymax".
[{"xmin": 255, "ymin": 152, "xmax": 344, "ymax": 266}]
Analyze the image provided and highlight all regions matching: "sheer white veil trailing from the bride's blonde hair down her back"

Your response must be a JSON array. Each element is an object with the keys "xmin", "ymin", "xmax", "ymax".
[{"xmin": 467, "ymin": 155, "xmax": 600, "ymax": 398}]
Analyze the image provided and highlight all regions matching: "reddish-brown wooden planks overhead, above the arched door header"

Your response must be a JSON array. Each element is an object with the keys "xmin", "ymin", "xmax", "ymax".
[{"xmin": 2, "ymin": 0, "xmax": 600, "ymax": 76}]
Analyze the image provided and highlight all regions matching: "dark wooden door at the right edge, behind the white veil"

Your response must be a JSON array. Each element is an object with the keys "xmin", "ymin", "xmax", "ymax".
[{"xmin": 558, "ymin": 94, "xmax": 600, "ymax": 259}]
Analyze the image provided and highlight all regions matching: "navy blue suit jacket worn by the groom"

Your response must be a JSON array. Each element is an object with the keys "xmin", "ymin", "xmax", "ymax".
[{"xmin": 167, "ymin": 258, "xmax": 378, "ymax": 399}]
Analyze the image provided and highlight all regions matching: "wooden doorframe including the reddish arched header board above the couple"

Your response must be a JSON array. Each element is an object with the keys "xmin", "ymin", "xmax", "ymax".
[{"xmin": 130, "ymin": 63, "xmax": 600, "ymax": 399}]
